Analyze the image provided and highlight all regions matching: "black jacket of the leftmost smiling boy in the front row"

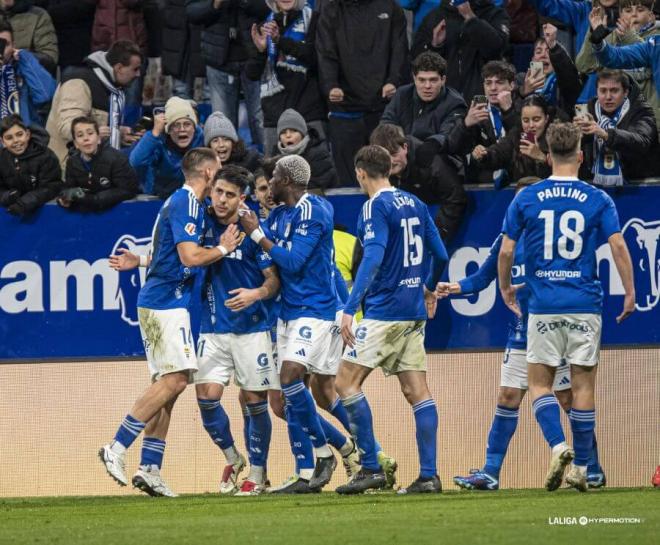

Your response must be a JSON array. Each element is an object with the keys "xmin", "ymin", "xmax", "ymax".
[{"xmin": 0, "ymin": 141, "xmax": 63, "ymax": 213}]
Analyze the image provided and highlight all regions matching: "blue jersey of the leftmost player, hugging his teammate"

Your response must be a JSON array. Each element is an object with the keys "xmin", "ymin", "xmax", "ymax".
[{"xmin": 138, "ymin": 185, "xmax": 205, "ymax": 310}]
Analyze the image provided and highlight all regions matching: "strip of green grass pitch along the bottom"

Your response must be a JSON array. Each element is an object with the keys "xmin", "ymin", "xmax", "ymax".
[{"xmin": 0, "ymin": 488, "xmax": 660, "ymax": 545}]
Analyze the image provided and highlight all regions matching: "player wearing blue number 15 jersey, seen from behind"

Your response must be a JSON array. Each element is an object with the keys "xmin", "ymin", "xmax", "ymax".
[{"xmin": 337, "ymin": 145, "xmax": 447, "ymax": 494}]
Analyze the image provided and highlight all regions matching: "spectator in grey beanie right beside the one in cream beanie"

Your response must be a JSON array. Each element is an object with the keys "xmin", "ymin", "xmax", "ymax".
[{"xmin": 204, "ymin": 112, "xmax": 263, "ymax": 172}]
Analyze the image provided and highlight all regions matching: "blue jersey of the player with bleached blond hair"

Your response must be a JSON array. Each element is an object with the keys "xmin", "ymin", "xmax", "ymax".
[{"xmin": 266, "ymin": 193, "xmax": 337, "ymax": 320}]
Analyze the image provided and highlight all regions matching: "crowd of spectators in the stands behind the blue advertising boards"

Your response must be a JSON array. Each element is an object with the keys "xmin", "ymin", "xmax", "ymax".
[{"xmin": 0, "ymin": 0, "xmax": 660, "ymax": 241}]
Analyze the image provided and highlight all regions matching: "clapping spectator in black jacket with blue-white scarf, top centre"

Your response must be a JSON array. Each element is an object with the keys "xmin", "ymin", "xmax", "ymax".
[{"xmin": 245, "ymin": 0, "xmax": 327, "ymax": 154}]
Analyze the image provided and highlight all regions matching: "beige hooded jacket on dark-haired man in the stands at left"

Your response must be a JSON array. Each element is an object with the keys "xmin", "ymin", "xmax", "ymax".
[{"xmin": 46, "ymin": 51, "xmax": 124, "ymax": 166}]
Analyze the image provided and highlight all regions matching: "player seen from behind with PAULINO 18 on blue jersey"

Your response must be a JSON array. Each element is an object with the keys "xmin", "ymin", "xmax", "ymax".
[{"xmin": 498, "ymin": 122, "xmax": 635, "ymax": 492}]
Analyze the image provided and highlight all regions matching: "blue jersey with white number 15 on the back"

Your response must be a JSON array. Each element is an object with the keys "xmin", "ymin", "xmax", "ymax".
[{"xmin": 358, "ymin": 188, "xmax": 436, "ymax": 321}]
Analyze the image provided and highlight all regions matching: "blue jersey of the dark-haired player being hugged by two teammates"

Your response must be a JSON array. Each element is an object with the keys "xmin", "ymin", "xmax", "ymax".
[{"xmin": 200, "ymin": 220, "xmax": 273, "ymax": 335}]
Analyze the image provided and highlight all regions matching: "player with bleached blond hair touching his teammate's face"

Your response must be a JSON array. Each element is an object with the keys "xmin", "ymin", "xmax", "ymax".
[{"xmin": 241, "ymin": 155, "xmax": 338, "ymax": 491}]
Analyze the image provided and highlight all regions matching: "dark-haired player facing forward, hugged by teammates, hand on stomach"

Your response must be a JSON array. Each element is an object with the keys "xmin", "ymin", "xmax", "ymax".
[{"xmin": 195, "ymin": 165, "xmax": 280, "ymax": 496}]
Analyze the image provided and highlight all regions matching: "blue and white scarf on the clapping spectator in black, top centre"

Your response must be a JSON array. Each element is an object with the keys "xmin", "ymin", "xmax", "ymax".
[{"xmin": 261, "ymin": 5, "xmax": 312, "ymax": 97}]
